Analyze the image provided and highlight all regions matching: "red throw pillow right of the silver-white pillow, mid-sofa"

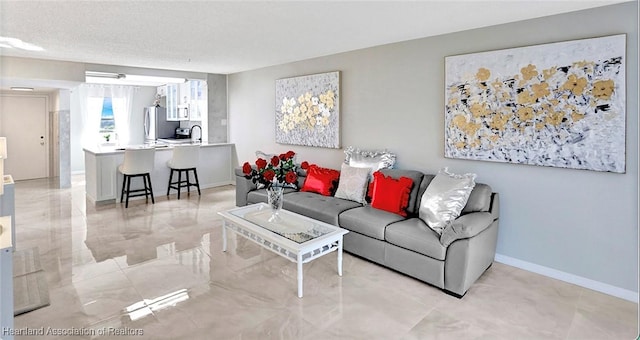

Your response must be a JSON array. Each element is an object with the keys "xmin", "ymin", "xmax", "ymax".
[{"xmin": 371, "ymin": 171, "xmax": 413, "ymax": 217}]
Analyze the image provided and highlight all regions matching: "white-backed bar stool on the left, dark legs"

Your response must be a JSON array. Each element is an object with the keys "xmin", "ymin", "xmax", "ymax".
[{"xmin": 118, "ymin": 148, "xmax": 156, "ymax": 208}]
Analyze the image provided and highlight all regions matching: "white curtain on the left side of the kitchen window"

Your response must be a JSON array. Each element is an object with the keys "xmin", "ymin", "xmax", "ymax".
[{"xmin": 79, "ymin": 84, "xmax": 105, "ymax": 147}]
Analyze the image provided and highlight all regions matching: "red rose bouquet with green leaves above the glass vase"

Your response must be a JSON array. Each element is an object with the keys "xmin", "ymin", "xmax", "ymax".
[{"xmin": 242, "ymin": 151, "xmax": 309, "ymax": 189}]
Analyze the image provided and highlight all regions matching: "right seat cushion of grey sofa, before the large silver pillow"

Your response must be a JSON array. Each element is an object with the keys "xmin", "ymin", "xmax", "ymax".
[{"xmin": 385, "ymin": 218, "xmax": 447, "ymax": 261}]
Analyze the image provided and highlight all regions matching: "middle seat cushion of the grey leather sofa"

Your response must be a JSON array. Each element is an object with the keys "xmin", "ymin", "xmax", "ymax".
[{"xmin": 339, "ymin": 206, "xmax": 404, "ymax": 241}]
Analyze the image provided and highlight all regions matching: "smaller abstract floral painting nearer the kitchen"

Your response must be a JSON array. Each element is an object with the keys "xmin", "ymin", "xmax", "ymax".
[{"xmin": 276, "ymin": 72, "xmax": 340, "ymax": 148}]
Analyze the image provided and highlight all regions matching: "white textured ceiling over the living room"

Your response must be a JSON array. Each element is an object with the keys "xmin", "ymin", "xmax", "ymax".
[{"xmin": 0, "ymin": 0, "xmax": 625, "ymax": 74}]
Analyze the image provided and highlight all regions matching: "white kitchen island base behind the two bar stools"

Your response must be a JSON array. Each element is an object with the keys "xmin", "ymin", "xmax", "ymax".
[{"xmin": 84, "ymin": 142, "xmax": 235, "ymax": 205}]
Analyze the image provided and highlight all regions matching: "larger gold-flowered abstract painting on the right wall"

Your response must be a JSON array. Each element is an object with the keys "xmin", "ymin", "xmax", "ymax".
[{"xmin": 445, "ymin": 35, "xmax": 626, "ymax": 173}]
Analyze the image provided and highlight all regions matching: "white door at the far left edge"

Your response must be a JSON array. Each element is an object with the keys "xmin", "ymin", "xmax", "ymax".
[{"xmin": 0, "ymin": 95, "xmax": 49, "ymax": 180}]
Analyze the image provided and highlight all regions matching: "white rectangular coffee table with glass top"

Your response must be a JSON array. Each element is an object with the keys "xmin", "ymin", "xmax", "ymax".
[{"xmin": 218, "ymin": 203, "xmax": 349, "ymax": 297}]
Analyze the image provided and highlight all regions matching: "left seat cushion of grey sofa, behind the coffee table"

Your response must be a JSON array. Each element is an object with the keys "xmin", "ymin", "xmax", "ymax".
[{"xmin": 282, "ymin": 191, "xmax": 362, "ymax": 226}]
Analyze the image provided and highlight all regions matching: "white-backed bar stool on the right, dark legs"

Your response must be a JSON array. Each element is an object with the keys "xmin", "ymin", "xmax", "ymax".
[{"xmin": 167, "ymin": 145, "xmax": 200, "ymax": 199}]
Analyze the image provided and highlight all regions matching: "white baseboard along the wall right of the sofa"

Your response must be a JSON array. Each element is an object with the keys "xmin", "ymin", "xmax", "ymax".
[{"xmin": 495, "ymin": 254, "xmax": 638, "ymax": 303}]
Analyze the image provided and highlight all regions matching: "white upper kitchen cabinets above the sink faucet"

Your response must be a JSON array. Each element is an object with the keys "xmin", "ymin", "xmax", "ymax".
[{"xmin": 158, "ymin": 80, "xmax": 207, "ymax": 121}]
